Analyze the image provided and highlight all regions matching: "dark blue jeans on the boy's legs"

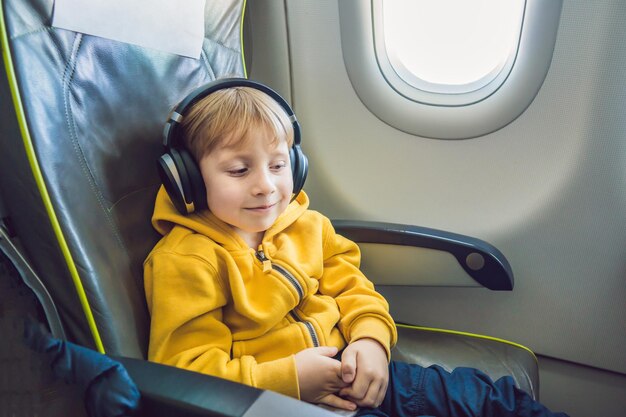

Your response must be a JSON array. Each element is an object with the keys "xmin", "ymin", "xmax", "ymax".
[{"xmin": 357, "ymin": 362, "xmax": 567, "ymax": 417}]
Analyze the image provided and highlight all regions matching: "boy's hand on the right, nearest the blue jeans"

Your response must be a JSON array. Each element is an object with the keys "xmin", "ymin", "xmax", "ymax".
[{"xmin": 339, "ymin": 338, "xmax": 389, "ymax": 408}]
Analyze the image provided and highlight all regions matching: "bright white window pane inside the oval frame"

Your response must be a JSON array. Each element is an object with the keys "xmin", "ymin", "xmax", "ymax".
[{"xmin": 374, "ymin": 0, "xmax": 525, "ymax": 94}]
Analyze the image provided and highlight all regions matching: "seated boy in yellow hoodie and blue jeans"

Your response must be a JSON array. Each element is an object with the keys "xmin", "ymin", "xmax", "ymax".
[{"xmin": 144, "ymin": 80, "xmax": 568, "ymax": 416}]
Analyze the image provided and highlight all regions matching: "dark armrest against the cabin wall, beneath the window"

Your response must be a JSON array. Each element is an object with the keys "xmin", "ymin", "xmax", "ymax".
[{"xmin": 333, "ymin": 220, "xmax": 514, "ymax": 291}]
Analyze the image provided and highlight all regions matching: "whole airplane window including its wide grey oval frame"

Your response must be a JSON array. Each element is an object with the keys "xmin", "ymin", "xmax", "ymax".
[{"xmin": 338, "ymin": 0, "xmax": 563, "ymax": 139}]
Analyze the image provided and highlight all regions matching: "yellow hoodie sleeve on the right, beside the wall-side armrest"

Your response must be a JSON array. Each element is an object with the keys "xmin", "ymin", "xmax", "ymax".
[{"xmin": 320, "ymin": 219, "xmax": 397, "ymax": 359}]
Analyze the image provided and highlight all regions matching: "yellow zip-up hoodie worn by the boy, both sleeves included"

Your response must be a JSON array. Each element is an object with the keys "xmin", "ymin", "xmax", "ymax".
[{"xmin": 144, "ymin": 187, "xmax": 397, "ymax": 398}]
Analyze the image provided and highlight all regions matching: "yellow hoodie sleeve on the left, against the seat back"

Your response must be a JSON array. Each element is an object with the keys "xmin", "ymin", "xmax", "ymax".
[{"xmin": 144, "ymin": 250, "xmax": 299, "ymax": 398}]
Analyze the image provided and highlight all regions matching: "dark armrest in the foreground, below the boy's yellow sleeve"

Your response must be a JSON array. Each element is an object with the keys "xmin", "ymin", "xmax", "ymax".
[{"xmin": 115, "ymin": 357, "xmax": 336, "ymax": 417}]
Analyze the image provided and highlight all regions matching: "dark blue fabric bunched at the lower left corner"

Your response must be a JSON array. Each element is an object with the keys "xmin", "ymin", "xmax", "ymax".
[{"xmin": 24, "ymin": 320, "xmax": 140, "ymax": 417}]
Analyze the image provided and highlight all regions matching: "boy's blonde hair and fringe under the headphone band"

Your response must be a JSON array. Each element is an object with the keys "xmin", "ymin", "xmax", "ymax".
[{"xmin": 181, "ymin": 87, "xmax": 294, "ymax": 162}]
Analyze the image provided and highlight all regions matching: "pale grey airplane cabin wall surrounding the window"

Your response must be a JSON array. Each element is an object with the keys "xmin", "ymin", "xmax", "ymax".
[{"xmin": 246, "ymin": 0, "xmax": 626, "ymax": 417}]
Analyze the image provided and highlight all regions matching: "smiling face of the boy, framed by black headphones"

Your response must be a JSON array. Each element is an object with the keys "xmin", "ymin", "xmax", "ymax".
[{"xmin": 199, "ymin": 125, "xmax": 293, "ymax": 247}]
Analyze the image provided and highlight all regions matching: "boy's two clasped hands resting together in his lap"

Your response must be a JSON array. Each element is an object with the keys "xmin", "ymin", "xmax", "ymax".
[{"xmin": 295, "ymin": 339, "xmax": 389, "ymax": 410}]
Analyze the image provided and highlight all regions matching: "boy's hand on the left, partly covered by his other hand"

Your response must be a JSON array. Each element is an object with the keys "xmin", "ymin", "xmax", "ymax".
[{"xmin": 295, "ymin": 347, "xmax": 356, "ymax": 410}]
